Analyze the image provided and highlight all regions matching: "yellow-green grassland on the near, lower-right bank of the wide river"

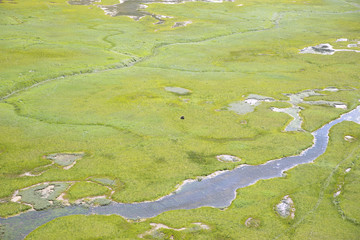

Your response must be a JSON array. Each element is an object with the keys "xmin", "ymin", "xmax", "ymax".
[{"xmin": 23, "ymin": 123, "xmax": 360, "ymax": 239}]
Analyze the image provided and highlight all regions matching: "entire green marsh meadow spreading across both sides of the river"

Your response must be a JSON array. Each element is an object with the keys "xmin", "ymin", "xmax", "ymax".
[{"xmin": 0, "ymin": 0, "xmax": 360, "ymax": 239}]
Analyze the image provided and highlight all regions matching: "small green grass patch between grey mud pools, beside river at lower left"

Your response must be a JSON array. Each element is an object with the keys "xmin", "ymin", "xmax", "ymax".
[{"xmin": 66, "ymin": 182, "xmax": 110, "ymax": 201}]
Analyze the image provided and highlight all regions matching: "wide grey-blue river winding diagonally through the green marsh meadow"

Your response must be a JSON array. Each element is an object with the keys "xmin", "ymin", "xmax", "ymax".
[{"xmin": 0, "ymin": 106, "xmax": 360, "ymax": 239}]
